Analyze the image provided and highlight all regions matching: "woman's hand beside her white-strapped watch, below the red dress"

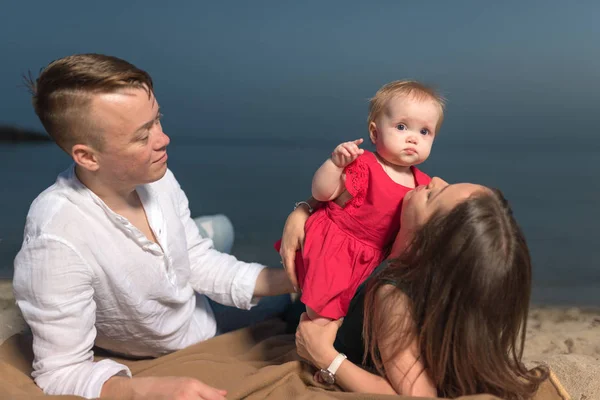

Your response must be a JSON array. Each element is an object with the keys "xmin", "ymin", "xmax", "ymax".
[{"xmin": 296, "ymin": 313, "xmax": 342, "ymax": 369}]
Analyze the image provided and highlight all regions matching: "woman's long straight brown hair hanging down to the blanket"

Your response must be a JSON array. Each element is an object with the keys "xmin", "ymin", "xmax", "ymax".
[{"xmin": 363, "ymin": 190, "xmax": 548, "ymax": 400}]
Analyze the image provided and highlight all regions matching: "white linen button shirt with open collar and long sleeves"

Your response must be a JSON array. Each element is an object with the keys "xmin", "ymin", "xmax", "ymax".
[{"xmin": 13, "ymin": 166, "xmax": 264, "ymax": 398}]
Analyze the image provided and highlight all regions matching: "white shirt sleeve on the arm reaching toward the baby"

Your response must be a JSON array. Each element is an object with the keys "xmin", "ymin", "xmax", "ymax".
[{"xmin": 173, "ymin": 172, "xmax": 265, "ymax": 310}]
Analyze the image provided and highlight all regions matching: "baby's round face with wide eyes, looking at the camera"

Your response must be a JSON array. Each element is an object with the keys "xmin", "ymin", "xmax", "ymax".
[{"xmin": 369, "ymin": 97, "xmax": 441, "ymax": 167}]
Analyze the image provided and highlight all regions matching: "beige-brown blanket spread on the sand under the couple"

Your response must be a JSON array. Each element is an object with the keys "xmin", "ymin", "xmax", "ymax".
[{"xmin": 0, "ymin": 320, "xmax": 569, "ymax": 400}]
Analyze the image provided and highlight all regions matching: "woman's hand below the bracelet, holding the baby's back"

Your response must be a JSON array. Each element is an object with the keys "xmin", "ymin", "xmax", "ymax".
[{"xmin": 279, "ymin": 205, "xmax": 310, "ymax": 292}]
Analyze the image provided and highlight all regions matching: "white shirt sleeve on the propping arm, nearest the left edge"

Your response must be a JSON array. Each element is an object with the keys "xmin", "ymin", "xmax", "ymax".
[{"xmin": 13, "ymin": 235, "xmax": 131, "ymax": 398}]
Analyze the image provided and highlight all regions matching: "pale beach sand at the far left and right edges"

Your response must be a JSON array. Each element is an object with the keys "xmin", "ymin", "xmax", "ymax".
[{"xmin": 0, "ymin": 280, "xmax": 600, "ymax": 400}]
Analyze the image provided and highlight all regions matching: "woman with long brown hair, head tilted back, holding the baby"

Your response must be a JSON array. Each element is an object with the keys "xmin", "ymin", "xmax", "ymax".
[{"xmin": 282, "ymin": 178, "xmax": 547, "ymax": 400}]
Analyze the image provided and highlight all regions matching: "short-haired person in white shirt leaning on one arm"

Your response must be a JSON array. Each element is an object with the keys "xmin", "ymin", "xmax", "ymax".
[{"xmin": 13, "ymin": 54, "xmax": 293, "ymax": 399}]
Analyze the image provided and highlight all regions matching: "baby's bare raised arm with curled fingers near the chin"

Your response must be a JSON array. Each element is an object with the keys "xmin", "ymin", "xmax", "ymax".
[{"xmin": 312, "ymin": 139, "xmax": 364, "ymax": 201}]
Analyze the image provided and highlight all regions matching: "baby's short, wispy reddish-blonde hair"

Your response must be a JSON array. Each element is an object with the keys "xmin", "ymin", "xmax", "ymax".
[{"xmin": 367, "ymin": 80, "xmax": 446, "ymax": 133}]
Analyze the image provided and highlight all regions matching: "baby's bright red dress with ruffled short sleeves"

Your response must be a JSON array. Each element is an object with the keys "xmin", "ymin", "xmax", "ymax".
[{"xmin": 276, "ymin": 150, "xmax": 431, "ymax": 319}]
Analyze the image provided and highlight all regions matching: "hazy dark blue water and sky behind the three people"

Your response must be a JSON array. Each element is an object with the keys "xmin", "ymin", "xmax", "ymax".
[{"xmin": 0, "ymin": 0, "xmax": 600, "ymax": 305}]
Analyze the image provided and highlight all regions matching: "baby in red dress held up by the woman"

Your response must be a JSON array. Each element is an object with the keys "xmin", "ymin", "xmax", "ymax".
[{"xmin": 276, "ymin": 81, "xmax": 444, "ymax": 324}]
